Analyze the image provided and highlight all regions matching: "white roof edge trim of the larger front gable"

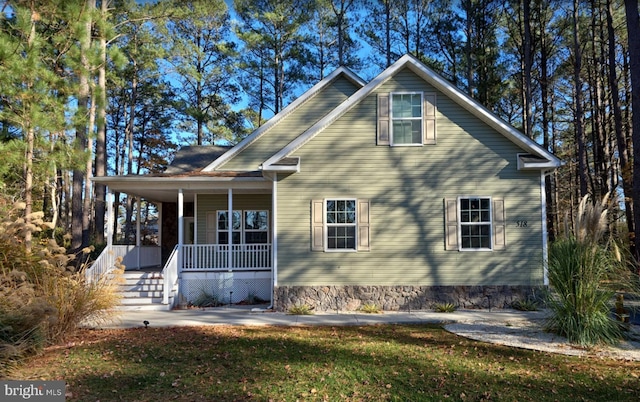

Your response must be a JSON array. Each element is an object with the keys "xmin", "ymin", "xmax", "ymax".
[{"xmin": 262, "ymin": 54, "xmax": 562, "ymax": 171}]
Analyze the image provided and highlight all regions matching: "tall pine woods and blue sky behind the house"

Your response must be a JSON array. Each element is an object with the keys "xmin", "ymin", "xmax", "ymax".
[{"xmin": 0, "ymin": 0, "xmax": 640, "ymax": 266}]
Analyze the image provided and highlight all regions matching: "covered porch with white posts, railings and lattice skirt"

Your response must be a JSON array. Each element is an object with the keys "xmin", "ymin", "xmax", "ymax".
[{"xmin": 87, "ymin": 172, "xmax": 276, "ymax": 308}]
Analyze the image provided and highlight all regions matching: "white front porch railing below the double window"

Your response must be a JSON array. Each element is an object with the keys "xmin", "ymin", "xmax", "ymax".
[{"xmin": 182, "ymin": 244, "xmax": 271, "ymax": 271}]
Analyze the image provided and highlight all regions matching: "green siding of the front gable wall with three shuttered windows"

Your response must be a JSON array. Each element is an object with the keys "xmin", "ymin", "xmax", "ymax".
[{"xmin": 278, "ymin": 70, "xmax": 543, "ymax": 286}]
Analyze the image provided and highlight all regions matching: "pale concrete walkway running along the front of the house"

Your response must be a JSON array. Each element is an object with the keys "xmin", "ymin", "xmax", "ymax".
[{"xmin": 86, "ymin": 306, "xmax": 546, "ymax": 328}]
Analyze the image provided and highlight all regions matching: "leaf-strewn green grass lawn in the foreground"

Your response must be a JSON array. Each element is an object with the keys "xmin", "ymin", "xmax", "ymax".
[{"xmin": 11, "ymin": 325, "xmax": 640, "ymax": 401}]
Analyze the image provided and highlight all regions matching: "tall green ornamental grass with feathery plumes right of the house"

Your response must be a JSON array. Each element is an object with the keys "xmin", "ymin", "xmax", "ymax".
[{"xmin": 546, "ymin": 196, "xmax": 629, "ymax": 346}]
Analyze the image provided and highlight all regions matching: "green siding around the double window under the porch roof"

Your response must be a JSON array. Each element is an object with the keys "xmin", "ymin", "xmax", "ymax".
[{"xmin": 196, "ymin": 193, "xmax": 273, "ymax": 244}]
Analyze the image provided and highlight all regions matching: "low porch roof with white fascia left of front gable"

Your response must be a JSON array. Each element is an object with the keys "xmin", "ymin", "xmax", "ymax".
[{"xmin": 92, "ymin": 171, "xmax": 271, "ymax": 202}]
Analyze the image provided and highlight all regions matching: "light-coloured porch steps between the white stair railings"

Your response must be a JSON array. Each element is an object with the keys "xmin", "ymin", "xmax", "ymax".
[{"xmin": 118, "ymin": 271, "xmax": 173, "ymax": 310}]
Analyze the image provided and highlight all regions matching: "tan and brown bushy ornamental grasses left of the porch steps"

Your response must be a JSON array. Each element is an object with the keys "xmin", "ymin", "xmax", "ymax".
[{"xmin": 0, "ymin": 200, "xmax": 122, "ymax": 378}]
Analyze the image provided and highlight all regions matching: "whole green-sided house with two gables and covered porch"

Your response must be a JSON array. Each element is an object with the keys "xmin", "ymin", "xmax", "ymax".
[{"xmin": 94, "ymin": 55, "xmax": 561, "ymax": 311}]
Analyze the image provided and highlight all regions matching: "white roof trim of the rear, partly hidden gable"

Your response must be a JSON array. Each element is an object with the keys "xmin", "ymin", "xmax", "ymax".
[{"xmin": 202, "ymin": 67, "xmax": 365, "ymax": 172}]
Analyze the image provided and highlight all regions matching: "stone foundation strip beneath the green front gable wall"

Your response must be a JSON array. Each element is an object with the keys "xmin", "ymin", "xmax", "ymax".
[{"xmin": 273, "ymin": 286, "xmax": 544, "ymax": 312}]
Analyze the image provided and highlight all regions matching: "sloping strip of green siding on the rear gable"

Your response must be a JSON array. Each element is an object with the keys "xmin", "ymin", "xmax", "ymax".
[{"xmin": 220, "ymin": 78, "xmax": 358, "ymax": 170}]
